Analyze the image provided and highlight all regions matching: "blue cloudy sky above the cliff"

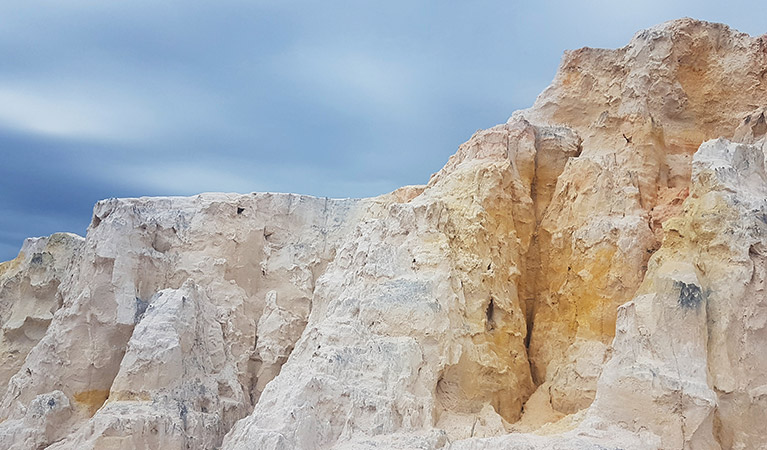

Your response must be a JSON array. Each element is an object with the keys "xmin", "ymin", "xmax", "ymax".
[{"xmin": 0, "ymin": 0, "xmax": 767, "ymax": 261}]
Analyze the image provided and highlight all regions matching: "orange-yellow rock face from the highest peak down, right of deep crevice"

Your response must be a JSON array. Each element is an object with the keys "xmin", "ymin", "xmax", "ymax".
[{"xmin": 512, "ymin": 19, "xmax": 767, "ymax": 413}]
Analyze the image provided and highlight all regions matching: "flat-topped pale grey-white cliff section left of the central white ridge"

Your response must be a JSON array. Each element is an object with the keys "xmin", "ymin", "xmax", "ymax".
[{"xmin": 0, "ymin": 194, "xmax": 364, "ymax": 448}]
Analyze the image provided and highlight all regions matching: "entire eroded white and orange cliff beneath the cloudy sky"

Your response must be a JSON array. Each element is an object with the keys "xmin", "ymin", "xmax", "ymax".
[{"xmin": 0, "ymin": 19, "xmax": 767, "ymax": 450}]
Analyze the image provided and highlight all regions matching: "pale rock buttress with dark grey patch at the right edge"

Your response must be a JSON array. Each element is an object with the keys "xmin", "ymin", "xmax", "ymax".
[{"xmin": 592, "ymin": 139, "xmax": 767, "ymax": 448}]
